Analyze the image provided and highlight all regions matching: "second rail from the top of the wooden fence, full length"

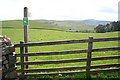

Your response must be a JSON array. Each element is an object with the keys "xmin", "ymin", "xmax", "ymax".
[{"xmin": 15, "ymin": 47, "xmax": 120, "ymax": 57}]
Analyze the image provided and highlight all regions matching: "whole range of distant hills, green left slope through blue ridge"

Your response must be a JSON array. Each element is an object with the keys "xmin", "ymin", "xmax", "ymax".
[{"xmin": 0, "ymin": 19, "xmax": 111, "ymax": 31}]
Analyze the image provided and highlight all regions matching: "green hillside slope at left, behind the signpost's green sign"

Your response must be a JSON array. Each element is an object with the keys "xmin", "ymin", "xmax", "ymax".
[{"xmin": 2, "ymin": 20, "xmax": 60, "ymax": 30}]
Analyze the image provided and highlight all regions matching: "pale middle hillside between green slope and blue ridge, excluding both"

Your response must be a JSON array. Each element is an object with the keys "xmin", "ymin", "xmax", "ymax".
[{"xmin": 36, "ymin": 20, "xmax": 95, "ymax": 30}]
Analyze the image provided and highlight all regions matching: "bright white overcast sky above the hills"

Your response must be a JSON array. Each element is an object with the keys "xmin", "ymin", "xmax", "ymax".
[{"xmin": 0, "ymin": 0, "xmax": 120, "ymax": 21}]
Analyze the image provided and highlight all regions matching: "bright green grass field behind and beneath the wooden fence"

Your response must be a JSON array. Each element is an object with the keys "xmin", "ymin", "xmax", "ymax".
[{"xmin": 2, "ymin": 20, "xmax": 119, "ymax": 80}]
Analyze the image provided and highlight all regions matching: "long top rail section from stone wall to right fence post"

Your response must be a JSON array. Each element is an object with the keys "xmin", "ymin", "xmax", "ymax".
[{"xmin": 14, "ymin": 39, "xmax": 88, "ymax": 47}]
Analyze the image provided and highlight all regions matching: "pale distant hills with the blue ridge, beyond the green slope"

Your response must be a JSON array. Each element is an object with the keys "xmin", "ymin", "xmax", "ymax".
[{"xmin": 35, "ymin": 19, "xmax": 112, "ymax": 30}]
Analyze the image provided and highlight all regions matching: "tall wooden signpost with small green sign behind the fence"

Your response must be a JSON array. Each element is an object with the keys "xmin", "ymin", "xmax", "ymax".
[{"xmin": 23, "ymin": 7, "xmax": 28, "ymax": 69}]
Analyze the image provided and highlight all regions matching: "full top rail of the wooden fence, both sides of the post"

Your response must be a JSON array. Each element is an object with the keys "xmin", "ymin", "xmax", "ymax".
[{"xmin": 14, "ymin": 37, "xmax": 120, "ymax": 47}]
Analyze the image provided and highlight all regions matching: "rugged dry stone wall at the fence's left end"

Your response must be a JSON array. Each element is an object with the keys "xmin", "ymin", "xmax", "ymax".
[{"xmin": 0, "ymin": 36, "xmax": 17, "ymax": 80}]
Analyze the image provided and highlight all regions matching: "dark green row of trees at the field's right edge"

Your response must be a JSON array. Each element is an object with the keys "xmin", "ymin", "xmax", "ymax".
[{"xmin": 94, "ymin": 21, "xmax": 120, "ymax": 33}]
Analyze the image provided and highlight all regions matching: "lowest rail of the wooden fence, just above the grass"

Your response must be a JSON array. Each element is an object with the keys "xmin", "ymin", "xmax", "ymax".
[{"xmin": 20, "ymin": 68, "xmax": 120, "ymax": 76}]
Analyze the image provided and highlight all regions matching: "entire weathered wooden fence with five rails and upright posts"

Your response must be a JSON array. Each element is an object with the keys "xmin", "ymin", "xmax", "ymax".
[{"xmin": 14, "ymin": 37, "xmax": 120, "ymax": 76}]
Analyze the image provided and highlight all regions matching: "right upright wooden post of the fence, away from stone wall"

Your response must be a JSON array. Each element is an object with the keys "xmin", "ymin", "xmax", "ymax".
[{"xmin": 86, "ymin": 37, "xmax": 93, "ymax": 78}]
